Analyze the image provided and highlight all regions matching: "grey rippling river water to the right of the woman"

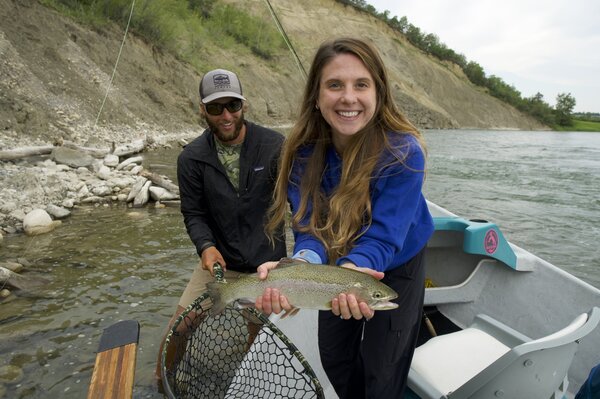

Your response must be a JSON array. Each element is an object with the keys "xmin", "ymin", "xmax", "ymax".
[{"xmin": 425, "ymin": 131, "xmax": 600, "ymax": 287}]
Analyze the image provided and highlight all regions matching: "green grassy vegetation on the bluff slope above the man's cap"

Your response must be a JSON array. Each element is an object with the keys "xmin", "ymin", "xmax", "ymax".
[{"xmin": 41, "ymin": 0, "xmax": 286, "ymax": 68}]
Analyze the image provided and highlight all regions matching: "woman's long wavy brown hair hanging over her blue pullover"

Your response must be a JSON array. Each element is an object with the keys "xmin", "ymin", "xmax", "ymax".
[{"xmin": 266, "ymin": 38, "xmax": 425, "ymax": 264}]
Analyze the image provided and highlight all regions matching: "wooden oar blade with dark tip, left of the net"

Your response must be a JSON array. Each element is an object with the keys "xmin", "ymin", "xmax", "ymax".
[{"xmin": 88, "ymin": 320, "xmax": 140, "ymax": 399}]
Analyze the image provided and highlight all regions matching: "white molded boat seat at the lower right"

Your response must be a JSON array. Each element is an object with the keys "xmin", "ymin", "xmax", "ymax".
[{"xmin": 408, "ymin": 307, "xmax": 600, "ymax": 399}]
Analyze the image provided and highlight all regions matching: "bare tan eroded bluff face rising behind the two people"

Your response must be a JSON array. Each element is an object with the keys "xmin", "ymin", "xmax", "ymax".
[{"xmin": 0, "ymin": 0, "xmax": 543, "ymax": 147}]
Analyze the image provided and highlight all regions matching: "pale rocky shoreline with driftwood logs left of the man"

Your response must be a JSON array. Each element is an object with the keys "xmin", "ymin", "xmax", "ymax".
[{"xmin": 0, "ymin": 127, "xmax": 201, "ymax": 245}]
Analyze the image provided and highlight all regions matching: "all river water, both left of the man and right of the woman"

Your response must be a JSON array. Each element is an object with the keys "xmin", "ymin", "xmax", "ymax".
[{"xmin": 0, "ymin": 130, "xmax": 600, "ymax": 399}]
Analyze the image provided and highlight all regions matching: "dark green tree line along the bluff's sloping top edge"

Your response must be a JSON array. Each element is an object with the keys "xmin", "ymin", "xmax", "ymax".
[{"xmin": 336, "ymin": 0, "xmax": 576, "ymax": 126}]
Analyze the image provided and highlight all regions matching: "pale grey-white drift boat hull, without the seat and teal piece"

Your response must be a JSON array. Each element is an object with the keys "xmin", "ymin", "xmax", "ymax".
[{"xmin": 273, "ymin": 203, "xmax": 600, "ymax": 398}]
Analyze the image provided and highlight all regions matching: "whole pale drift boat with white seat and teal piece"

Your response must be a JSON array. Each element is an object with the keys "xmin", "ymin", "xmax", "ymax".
[{"xmin": 274, "ymin": 203, "xmax": 600, "ymax": 399}]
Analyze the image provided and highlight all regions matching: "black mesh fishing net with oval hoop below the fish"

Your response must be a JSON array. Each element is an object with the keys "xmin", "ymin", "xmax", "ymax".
[{"xmin": 162, "ymin": 270, "xmax": 324, "ymax": 399}]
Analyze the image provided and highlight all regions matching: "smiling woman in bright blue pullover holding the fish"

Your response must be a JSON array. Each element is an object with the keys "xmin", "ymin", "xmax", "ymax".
[{"xmin": 256, "ymin": 38, "xmax": 433, "ymax": 399}]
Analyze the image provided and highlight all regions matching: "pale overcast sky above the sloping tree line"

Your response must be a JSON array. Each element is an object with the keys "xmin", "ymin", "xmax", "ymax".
[{"xmin": 367, "ymin": 0, "xmax": 600, "ymax": 112}]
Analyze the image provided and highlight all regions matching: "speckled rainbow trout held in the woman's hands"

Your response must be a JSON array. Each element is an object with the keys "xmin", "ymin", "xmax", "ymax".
[{"xmin": 206, "ymin": 261, "xmax": 398, "ymax": 314}]
